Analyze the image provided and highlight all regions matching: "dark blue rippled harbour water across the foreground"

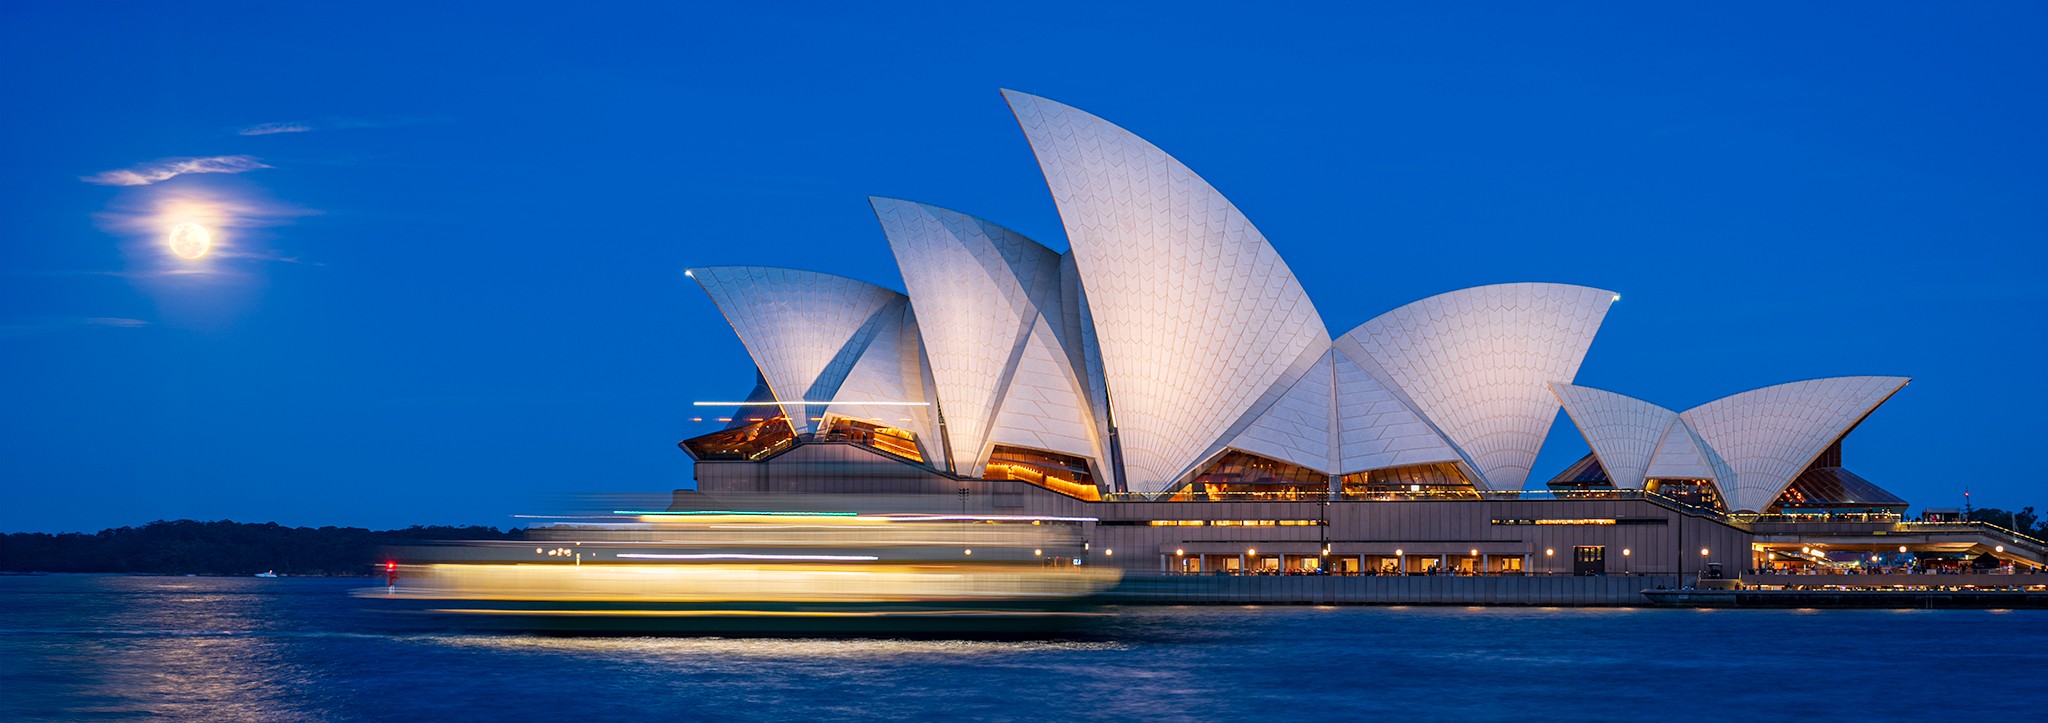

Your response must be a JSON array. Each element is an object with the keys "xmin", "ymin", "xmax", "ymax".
[{"xmin": 0, "ymin": 576, "xmax": 2048, "ymax": 721}]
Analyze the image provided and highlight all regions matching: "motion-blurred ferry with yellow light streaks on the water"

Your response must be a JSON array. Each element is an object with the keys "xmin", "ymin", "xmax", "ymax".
[{"xmin": 356, "ymin": 510, "xmax": 1120, "ymax": 635}]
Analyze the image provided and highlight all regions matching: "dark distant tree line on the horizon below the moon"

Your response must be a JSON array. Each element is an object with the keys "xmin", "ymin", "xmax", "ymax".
[{"xmin": 0, "ymin": 520, "xmax": 526, "ymax": 576}]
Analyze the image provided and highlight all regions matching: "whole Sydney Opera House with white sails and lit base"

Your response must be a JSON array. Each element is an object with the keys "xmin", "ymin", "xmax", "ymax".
[{"xmin": 682, "ymin": 92, "xmax": 2040, "ymax": 598}]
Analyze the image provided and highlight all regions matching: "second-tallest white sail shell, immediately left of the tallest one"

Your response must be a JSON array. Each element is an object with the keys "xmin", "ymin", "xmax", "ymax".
[{"xmin": 868, "ymin": 199, "xmax": 1098, "ymax": 477}]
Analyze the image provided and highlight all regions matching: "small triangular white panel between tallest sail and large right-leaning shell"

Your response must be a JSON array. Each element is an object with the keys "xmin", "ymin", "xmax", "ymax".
[{"xmin": 1333, "ymin": 348, "xmax": 1460, "ymax": 475}]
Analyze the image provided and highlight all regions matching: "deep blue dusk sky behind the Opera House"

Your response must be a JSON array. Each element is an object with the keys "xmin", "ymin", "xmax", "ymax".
[{"xmin": 0, "ymin": 2, "xmax": 2048, "ymax": 530}]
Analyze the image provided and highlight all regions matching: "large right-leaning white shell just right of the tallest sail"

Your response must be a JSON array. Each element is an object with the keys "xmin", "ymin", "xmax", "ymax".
[{"xmin": 1337, "ymin": 283, "xmax": 1614, "ymax": 490}]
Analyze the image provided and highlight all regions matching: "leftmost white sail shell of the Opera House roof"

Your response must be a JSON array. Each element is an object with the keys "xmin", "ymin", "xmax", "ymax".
[{"xmin": 688, "ymin": 266, "xmax": 907, "ymax": 434}]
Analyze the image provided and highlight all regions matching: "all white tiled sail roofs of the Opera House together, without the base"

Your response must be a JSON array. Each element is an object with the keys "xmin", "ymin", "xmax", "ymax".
[{"xmin": 692, "ymin": 90, "xmax": 1905, "ymax": 503}]
